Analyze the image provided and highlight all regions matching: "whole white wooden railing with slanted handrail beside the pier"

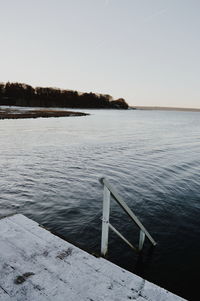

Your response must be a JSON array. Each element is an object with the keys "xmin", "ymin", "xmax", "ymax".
[{"xmin": 100, "ymin": 178, "xmax": 156, "ymax": 256}]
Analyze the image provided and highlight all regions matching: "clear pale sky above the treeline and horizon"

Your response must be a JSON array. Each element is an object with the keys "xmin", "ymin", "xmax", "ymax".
[{"xmin": 0, "ymin": 0, "xmax": 200, "ymax": 108}]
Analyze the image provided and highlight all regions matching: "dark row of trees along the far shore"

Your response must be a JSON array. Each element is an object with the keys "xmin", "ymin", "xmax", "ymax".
[{"xmin": 0, "ymin": 82, "xmax": 128, "ymax": 109}]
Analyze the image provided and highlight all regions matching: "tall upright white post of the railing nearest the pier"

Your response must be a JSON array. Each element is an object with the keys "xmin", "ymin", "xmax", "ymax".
[{"xmin": 101, "ymin": 185, "xmax": 110, "ymax": 256}]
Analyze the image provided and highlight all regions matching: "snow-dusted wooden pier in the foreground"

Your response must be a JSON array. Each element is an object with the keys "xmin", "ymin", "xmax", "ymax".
[{"xmin": 0, "ymin": 214, "xmax": 184, "ymax": 301}]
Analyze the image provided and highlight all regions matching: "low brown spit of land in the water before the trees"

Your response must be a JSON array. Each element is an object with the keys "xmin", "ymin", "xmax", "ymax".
[{"xmin": 0, "ymin": 108, "xmax": 89, "ymax": 119}]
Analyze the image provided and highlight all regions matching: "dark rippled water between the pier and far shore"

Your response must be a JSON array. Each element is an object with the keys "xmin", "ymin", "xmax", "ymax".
[{"xmin": 0, "ymin": 110, "xmax": 200, "ymax": 300}]
